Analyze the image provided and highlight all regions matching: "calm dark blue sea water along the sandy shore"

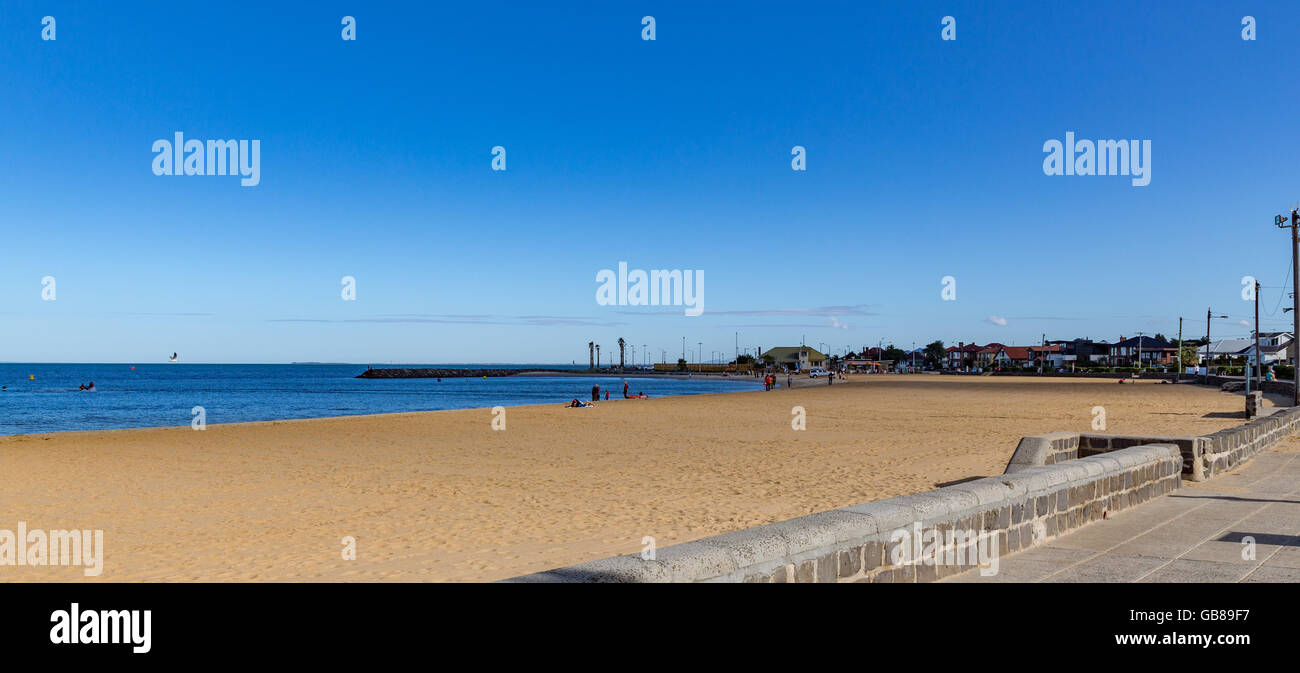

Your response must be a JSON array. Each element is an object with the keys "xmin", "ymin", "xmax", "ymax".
[{"xmin": 0, "ymin": 364, "xmax": 762, "ymax": 435}]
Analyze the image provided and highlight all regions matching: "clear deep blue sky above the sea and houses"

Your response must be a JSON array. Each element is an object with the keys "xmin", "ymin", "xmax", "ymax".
[{"xmin": 0, "ymin": 0, "xmax": 1300, "ymax": 362}]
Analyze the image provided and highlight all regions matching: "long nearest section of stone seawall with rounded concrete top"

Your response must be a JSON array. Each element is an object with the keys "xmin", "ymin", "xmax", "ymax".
[{"xmin": 506, "ymin": 444, "xmax": 1182, "ymax": 583}]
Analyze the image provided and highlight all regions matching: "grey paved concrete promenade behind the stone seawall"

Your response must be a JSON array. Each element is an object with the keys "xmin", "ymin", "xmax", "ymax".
[{"xmin": 943, "ymin": 437, "xmax": 1300, "ymax": 582}]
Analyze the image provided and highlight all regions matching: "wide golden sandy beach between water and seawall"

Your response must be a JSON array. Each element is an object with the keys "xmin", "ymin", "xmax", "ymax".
[{"xmin": 0, "ymin": 375, "xmax": 1273, "ymax": 582}]
